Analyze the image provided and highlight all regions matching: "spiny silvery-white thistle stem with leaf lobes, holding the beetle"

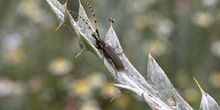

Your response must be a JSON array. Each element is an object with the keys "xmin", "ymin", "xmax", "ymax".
[{"xmin": 47, "ymin": 0, "xmax": 211, "ymax": 110}]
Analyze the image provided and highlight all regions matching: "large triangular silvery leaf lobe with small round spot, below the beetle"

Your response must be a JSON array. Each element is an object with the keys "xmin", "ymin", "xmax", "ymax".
[{"xmin": 147, "ymin": 54, "xmax": 193, "ymax": 110}]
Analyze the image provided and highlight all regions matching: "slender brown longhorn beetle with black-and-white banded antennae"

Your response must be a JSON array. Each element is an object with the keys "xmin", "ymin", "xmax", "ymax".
[{"xmin": 69, "ymin": 1, "xmax": 125, "ymax": 71}]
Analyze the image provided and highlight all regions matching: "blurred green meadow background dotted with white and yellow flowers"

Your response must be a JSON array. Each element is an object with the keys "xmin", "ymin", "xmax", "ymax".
[{"xmin": 0, "ymin": 0, "xmax": 220, "ymax": 110}]
